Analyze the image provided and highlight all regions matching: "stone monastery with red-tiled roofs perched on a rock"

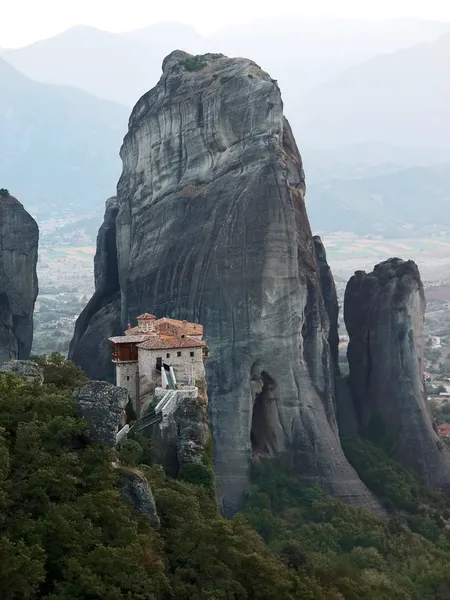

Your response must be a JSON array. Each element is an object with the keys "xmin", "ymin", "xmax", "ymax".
[{"xmin": 109, "ymin": 313, "xmax": 208, "ymax": 416}]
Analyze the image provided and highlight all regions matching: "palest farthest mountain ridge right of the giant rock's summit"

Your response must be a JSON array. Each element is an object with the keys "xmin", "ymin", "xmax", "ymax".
[{"xmin": 209, "ymin": 17, "xmax": 450, "ymax": 122}]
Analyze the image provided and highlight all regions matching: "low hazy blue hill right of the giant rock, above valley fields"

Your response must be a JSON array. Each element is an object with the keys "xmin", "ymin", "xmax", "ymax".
[{"xmin": 306, "ymin": 168, "xmax": 450, "ymax": 237}]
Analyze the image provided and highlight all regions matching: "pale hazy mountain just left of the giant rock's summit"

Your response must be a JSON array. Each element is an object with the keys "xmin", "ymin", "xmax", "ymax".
[{"xmin": 4, "ymin": 25, "xmax": 162, "ymax": 106}]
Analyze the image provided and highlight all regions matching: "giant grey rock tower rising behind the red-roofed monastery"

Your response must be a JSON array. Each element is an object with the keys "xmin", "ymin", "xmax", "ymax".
[{"xmin": 71, "ymin": 51, "xmax": 377, "ymax": 514}]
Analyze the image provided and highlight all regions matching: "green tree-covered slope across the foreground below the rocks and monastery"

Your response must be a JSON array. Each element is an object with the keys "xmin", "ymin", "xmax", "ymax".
[{"xmin": 0, "ymin": 356, "xmax": 450, "ymax": 600}]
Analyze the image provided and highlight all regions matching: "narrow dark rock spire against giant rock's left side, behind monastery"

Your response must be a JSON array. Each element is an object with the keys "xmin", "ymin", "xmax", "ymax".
[{"xmin": 69, "ymin": 197, "xmax": 122, "ymax": 382}]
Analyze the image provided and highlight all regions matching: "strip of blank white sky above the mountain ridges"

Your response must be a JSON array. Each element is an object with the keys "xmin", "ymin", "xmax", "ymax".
[{"xmin": 0, "ymin": 0, "xmax": 450, "ymax": 47}]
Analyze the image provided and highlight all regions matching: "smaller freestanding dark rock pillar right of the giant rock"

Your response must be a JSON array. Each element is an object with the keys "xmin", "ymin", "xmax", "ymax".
[{"xmin": 344, "ymin": 258, "xmax": 450, "ymax": 491}]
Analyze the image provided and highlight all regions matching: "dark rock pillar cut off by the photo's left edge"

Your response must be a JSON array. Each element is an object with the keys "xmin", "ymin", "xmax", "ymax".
[{"xmin": 0, "ymin": 193, "xmax": 39, "ymax": 365}]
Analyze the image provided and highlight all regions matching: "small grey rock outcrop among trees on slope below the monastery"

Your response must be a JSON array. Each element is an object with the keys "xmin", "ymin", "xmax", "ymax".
[{"xmin": 119, "ymin": 467, "xmax": 161, "ymax": 529}]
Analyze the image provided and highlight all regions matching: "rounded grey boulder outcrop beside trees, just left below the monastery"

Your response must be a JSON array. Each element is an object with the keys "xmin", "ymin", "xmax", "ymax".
[{"xmin": 74, "ymin": 381, "xmax": 128, "ymax": 447}]
